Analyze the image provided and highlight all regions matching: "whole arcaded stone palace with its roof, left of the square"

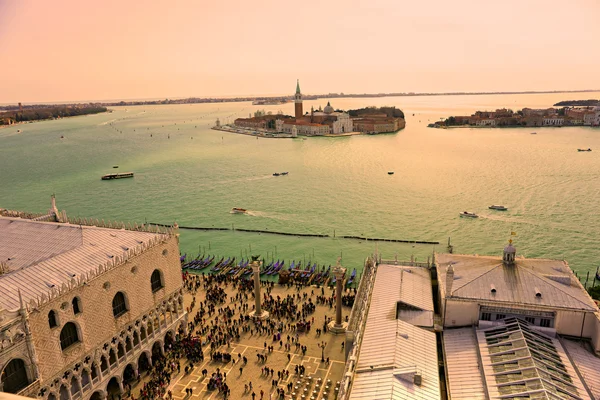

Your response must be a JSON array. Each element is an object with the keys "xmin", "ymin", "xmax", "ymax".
[{"xmin": 0, "ymin": 198, "xmax": 187, "ymax": 400}]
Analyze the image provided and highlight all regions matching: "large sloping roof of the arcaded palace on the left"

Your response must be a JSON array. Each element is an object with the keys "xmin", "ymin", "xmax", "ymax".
[{"xmin": 0, "ymin": 217, "xmax": 164, "ymax": 310}]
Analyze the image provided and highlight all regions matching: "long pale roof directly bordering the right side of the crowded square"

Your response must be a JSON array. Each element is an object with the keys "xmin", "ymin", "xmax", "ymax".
[{"xmin": 349, "ymin": 265, "xmax": 440, "ymax": 400}]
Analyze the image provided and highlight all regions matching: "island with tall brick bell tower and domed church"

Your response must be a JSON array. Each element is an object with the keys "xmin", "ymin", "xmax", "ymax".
[{"xmin": 213, "ymin": 82, "xmax": 406, "ymax": 138}]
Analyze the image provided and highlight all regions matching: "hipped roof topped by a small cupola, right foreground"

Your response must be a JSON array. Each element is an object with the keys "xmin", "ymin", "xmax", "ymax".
[{"xmin": 436, "ymin": 254, "xmax": 598, "ymax": 311}]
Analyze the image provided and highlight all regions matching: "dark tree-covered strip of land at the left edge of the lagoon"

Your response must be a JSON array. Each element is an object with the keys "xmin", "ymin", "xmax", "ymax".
[{"xmin": 0, "ymin": 105, "xmax": 108, "ymax": 125}]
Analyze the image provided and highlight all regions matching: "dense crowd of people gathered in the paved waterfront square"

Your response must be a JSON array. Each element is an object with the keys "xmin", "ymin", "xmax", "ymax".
[{"xmin": 125, "ymin": 273, "xmax": 354, "ymax": 400}]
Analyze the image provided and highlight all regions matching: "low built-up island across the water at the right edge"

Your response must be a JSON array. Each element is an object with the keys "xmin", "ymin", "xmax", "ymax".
[{"xmin": 428, "ymin": 107, "xmax": 600, "ymax": 128}]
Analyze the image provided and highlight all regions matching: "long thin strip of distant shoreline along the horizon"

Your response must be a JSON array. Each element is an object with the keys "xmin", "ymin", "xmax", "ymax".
[{"xmin": 0, "ymin": 89, "xmax": 600, "ymax": 111}]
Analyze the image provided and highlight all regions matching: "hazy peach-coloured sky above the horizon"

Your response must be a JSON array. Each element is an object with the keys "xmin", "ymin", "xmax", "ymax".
[{"xmin": 0, "ymin": 0, "xmax": 600, "ymax": 103}]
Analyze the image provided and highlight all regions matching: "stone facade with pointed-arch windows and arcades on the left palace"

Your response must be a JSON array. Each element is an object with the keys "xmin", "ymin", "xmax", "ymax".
[{"xmin": 0, "ymin": 209, "xmax": 187, "ymax": 400}]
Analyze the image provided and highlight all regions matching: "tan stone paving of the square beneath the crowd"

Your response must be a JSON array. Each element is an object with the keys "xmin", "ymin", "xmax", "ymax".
[{"xmin": 131, "ymin": 274, "xmax": 351, "ymax": 400}]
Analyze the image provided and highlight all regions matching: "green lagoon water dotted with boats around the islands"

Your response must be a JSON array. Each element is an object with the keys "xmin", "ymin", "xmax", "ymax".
[{"xmin": 0, "ymin": 94, "xmax": 600, "ymax": 282}]
